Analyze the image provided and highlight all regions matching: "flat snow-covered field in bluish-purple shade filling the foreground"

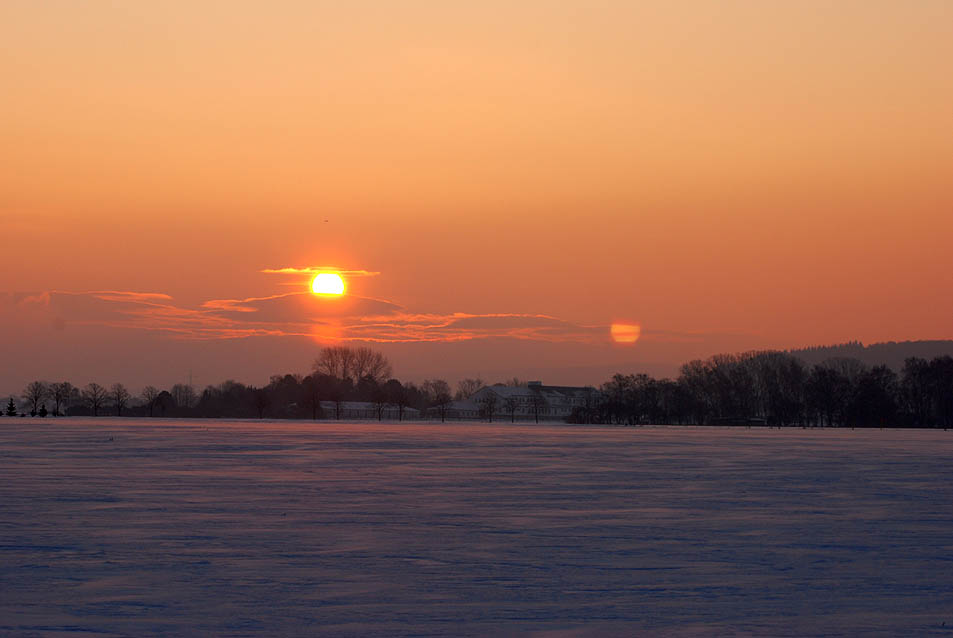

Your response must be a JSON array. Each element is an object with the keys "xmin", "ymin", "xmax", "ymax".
[{"xmin": 0, "ymin": 418, "xmax": 953, "ymax": 637}]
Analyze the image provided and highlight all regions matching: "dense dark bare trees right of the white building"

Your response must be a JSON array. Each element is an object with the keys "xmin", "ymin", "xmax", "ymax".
[{"xmin": 570, "ymin": 351, "xmax": 953, "ymax": 428}]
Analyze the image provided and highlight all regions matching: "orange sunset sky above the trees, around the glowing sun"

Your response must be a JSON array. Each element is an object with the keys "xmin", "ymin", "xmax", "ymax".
[{"xmin": 0, "ymin": 0, "xmax": 953, "ymax": 390}]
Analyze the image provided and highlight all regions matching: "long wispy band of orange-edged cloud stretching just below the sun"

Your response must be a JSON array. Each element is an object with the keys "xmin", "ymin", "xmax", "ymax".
[{"xmin": 7, "ymin": 290, "xmax": 607, "ymax": 343}]
